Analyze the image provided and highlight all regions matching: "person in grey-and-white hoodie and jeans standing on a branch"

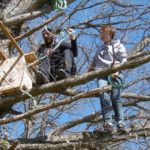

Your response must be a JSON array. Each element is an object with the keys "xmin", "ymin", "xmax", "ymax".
[{"xmin": 88, "ymin": 24, "xmax": 127, "ymax": 132}]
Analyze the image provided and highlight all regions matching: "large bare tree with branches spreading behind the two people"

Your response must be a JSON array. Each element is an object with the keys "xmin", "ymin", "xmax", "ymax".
[{"xmin": 0, "ymin": 0, "xmax": 150, "ymax": 150}]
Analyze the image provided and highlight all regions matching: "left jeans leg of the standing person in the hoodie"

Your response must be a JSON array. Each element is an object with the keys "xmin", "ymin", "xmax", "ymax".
[{"xmin": 98, "ymin": 79, "xmax": 112, "ymax": 129}]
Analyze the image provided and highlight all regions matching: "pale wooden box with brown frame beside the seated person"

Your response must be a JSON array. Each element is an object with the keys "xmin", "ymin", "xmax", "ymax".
[{"xmin": 0, "ymin": 21, "xmax": 37, "ymax": 95}]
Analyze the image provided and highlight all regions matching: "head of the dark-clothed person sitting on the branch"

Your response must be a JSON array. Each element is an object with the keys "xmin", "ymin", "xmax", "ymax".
[{"xmin": 42, "ymin": 28, "xmax": 56, "ymax": 44}]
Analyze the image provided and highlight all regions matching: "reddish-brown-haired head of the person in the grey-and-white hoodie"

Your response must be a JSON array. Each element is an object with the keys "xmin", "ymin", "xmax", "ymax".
[{"xmin": 100, "ymin": 25, "xmax": 116, "ymax": 43}]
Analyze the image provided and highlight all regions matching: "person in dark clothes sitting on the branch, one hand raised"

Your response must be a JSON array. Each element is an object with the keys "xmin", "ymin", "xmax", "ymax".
[{"xmin": 35, "ymin": 28, "xmax": 78, "ymax": 85}]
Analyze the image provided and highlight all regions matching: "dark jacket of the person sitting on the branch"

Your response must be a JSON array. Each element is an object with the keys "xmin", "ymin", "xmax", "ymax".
[{"xmin": 37, "ymin": 40, "xmax": 78, "ymax": 76}]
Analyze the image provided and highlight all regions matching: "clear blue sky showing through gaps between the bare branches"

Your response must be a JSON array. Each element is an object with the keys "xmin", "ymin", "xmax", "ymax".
[{"xmin": 1, "ymin": 0, "xmax": 150, "ymax": 147}]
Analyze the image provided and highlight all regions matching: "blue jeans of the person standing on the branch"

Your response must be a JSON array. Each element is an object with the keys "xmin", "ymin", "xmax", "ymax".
[{"xmin": 97, "ymin": 79, "xmax": 124, "ymax": 123}]
